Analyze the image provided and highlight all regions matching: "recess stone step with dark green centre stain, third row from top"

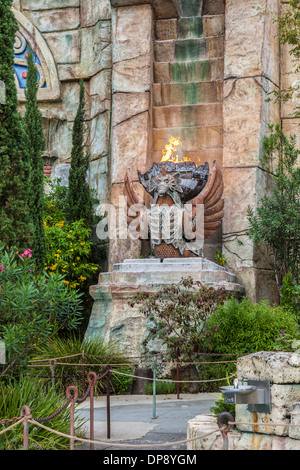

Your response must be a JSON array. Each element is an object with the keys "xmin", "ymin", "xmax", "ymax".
[{"xmin": 154, "ymin": 36, "xmax": 224, "ymax": 62}]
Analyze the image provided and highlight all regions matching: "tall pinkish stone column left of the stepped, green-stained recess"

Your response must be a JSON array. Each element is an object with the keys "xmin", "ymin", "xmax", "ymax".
[{"xmin": 109, "ymin": 1, "xmax": 153, "ymax": 266}]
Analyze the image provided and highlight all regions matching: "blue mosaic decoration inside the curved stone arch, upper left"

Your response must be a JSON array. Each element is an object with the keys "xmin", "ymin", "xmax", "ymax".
[{"xmin": 14, "ymin": 31, "xmax": 47, "ymax": 89}]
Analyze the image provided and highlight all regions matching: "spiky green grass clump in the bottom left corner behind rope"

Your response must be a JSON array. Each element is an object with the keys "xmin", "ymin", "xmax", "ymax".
[{"xmin": 0, "ymin": 375, "xmax": 85, "ymax": 450}]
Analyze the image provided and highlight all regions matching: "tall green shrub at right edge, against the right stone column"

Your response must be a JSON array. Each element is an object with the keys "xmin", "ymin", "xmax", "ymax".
[{"xmin": 248, "ymin": 125, "xmax": 300, "ymax": 289}]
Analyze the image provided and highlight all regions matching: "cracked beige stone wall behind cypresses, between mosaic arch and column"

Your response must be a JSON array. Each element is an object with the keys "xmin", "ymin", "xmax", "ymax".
[{"xmin": 14, "ymin": 0, "xmax": 112, "ymax": 206}]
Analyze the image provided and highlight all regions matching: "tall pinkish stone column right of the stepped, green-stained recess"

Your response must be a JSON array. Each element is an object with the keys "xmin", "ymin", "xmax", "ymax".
[{"xmin": 223, "ymin": 0, "xmax": 280, "ymax": 300}]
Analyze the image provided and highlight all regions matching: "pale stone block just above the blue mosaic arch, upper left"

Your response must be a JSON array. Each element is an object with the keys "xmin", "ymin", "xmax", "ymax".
[{"xmin": 30, "ymin": 8, "xmax": 80, "ymax": 33}]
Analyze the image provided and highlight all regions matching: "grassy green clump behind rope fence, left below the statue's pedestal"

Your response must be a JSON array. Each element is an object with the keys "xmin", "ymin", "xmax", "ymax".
[{"xmin": 31, "ymin": 335, "xmax": 134, "ymax": 395}]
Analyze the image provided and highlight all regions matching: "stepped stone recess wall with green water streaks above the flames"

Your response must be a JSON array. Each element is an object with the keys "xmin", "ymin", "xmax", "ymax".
[{"xmin": 152, "ymin": 0, "xmax": 225, "ymax": 259}]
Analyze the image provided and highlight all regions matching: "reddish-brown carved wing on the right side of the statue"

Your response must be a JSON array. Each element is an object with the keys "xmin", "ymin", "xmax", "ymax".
[{"xmin": 189, "ymin": 161, "xmax": 224, "ymax": 239}]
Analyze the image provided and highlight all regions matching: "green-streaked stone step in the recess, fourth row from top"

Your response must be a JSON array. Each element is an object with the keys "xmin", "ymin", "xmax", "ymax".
[{"xmin": 154, "ymin": 58, "xmax": 224, "ymax": 83}]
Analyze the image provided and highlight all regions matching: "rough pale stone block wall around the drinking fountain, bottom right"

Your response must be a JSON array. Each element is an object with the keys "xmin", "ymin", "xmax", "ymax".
[{"xmin": 188, "ymin": 352, "xmax": 300, "ymax": 450}]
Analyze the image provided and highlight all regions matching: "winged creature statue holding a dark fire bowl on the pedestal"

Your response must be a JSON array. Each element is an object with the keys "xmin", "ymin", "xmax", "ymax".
[{"xmin": 124, "ymin": 161, "xmax": 224, "ymax": 259}]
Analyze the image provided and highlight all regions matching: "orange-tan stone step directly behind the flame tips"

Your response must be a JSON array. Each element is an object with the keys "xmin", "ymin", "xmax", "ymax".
[{"xmin": 152, "ymin": 126, "xmax": 223, "ymax": 151}]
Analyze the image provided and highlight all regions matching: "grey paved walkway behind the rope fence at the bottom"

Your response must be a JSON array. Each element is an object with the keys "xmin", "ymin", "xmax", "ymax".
[{"xmin": 78, "ymin": 393, "xmax": 219, "ymax": 451}]
